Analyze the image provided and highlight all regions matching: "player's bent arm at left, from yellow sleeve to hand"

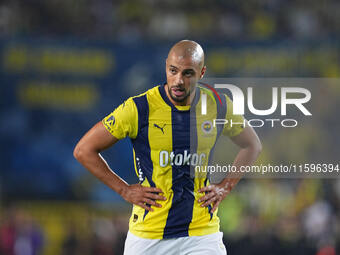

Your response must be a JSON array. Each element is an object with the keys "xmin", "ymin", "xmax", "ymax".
[{"xmin": 73, "ymin": 97, "xmax": 165, "ymax": 211}]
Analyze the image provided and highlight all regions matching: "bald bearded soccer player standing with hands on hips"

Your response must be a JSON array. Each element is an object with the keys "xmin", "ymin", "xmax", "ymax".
[{"xmin": 74, "ymin": 40, "xmax": 261, "ymax": 255}]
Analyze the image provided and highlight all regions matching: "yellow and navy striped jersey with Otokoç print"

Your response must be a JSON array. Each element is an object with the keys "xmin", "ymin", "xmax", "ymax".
[{"xmin": 103, "ymin": 85, "xmax": 243, "ymax": 239}]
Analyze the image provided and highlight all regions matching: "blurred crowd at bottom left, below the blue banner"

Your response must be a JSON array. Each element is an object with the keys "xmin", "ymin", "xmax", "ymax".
[{"xmin": 0, "ymin": 205, "xmax": 128, "ymax": 255}]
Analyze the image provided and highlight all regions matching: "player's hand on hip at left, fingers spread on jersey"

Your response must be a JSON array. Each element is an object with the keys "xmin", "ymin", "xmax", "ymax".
[{"xmin": 122, "ymin": 183, "xmax": 166, "ymax": 211}]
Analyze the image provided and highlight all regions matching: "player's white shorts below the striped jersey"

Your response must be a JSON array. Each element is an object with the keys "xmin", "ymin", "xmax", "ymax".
[{"xmin": 124, "ymin": 231, "xmax": 227, "ymax": 255}]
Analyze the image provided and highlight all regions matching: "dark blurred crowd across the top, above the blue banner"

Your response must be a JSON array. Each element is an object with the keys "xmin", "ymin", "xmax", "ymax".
[{"xmin": 0, "ymin": 0, "xmax": 340, "ymax": 43}]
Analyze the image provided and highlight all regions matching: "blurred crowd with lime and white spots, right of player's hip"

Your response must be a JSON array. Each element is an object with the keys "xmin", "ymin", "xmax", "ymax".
[{"xmin": 219, "ymin": 179, "xmax": 340, "ymax": 255}]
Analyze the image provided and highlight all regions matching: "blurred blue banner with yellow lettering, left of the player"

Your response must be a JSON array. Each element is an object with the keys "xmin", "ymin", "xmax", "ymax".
[{"xmin": 0, "ymin": 39, "xmax": 173, "ymax": 200}]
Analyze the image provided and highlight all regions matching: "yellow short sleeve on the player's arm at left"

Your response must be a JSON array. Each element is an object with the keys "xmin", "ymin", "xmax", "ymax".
[{"xmin": 102, "ymin": 98, "xmax": 138, "ymax": 139}]
